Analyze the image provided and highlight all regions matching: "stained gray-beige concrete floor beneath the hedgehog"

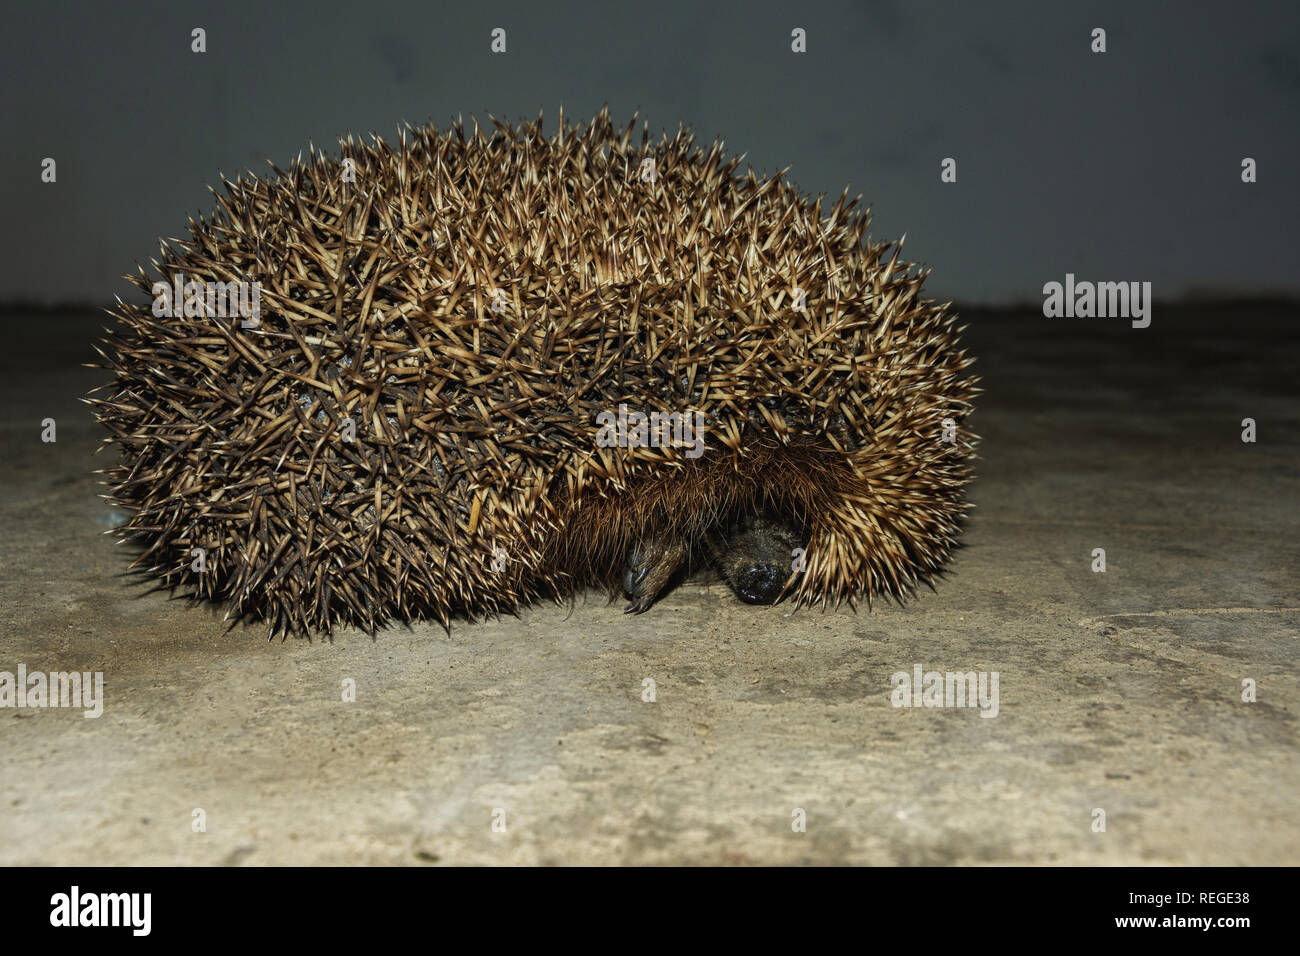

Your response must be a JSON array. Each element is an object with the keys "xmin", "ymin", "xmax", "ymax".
[{"xmin": 0, "ymin": 304, "xmax": 1300, "ymax": 865}]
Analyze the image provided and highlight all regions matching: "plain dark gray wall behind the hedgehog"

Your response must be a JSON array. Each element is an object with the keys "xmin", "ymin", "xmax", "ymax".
[{"xmin": 0, "ymin": 0, "xmax": 1300, "ymax": 303}]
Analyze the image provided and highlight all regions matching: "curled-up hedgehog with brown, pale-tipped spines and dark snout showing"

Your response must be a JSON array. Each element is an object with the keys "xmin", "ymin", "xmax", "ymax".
[{"xmin": 90, "ymin": 111, "xmax": 978, "ymax": 635}]
